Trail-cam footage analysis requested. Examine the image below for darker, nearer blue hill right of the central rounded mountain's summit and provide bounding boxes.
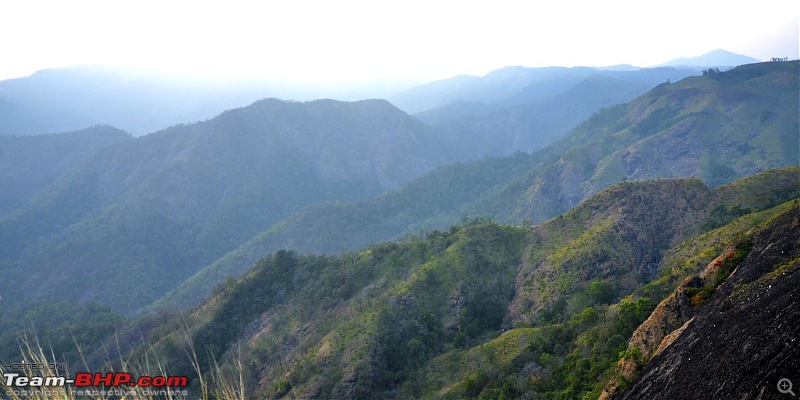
[415,68,693,158]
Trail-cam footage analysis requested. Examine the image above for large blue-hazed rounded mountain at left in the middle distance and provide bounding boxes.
[0,99,448,312]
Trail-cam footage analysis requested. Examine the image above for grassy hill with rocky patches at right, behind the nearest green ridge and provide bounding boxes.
[478,61,800,221]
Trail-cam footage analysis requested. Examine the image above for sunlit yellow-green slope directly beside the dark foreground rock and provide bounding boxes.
[408,201,798,399]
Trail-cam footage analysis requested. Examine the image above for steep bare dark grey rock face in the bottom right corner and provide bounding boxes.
[616,203,800,399]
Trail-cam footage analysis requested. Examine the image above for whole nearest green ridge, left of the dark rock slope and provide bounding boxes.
[125,168,800,398]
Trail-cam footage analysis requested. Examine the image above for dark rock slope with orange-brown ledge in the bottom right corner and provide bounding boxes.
[614,201,800,399]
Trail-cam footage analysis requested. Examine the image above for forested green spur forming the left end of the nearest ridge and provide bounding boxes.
[143,224,527,398]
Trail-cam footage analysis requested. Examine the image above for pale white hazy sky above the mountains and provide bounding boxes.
[0,0,800,80]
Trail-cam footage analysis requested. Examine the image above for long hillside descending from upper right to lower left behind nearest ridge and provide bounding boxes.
[159,61,800,305]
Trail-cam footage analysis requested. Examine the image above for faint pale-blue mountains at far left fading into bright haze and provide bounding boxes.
[0,65,422,136]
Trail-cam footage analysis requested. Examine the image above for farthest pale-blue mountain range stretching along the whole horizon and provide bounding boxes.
[0,50,758,138]
